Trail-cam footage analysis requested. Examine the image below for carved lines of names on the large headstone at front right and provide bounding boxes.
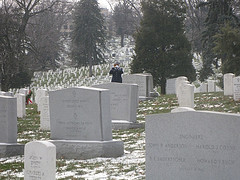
[146,134,236,171]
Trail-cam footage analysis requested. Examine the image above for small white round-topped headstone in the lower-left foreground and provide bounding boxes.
[24,141,56,180]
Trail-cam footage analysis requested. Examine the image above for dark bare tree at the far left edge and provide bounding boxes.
[0,0,60,91]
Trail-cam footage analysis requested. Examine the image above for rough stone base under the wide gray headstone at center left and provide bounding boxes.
[49,140,124,159]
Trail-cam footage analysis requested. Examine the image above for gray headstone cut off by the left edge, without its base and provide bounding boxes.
[0,96,17,143]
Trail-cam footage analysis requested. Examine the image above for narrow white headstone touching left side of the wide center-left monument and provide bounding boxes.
[40,96,50,130]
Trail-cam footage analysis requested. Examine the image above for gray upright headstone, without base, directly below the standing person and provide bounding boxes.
[94,83,138,122]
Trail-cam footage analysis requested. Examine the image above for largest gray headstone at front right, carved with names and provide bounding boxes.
[145,111,240,180]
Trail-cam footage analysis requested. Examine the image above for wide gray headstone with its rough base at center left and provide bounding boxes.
[49,87,124,159]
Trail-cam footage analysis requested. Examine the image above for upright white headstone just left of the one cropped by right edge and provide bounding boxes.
[223,73,235,96]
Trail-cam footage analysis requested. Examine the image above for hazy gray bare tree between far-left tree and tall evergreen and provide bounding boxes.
[26,2,73,70]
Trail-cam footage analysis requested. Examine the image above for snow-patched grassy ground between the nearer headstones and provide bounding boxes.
[0,92,240,180]
